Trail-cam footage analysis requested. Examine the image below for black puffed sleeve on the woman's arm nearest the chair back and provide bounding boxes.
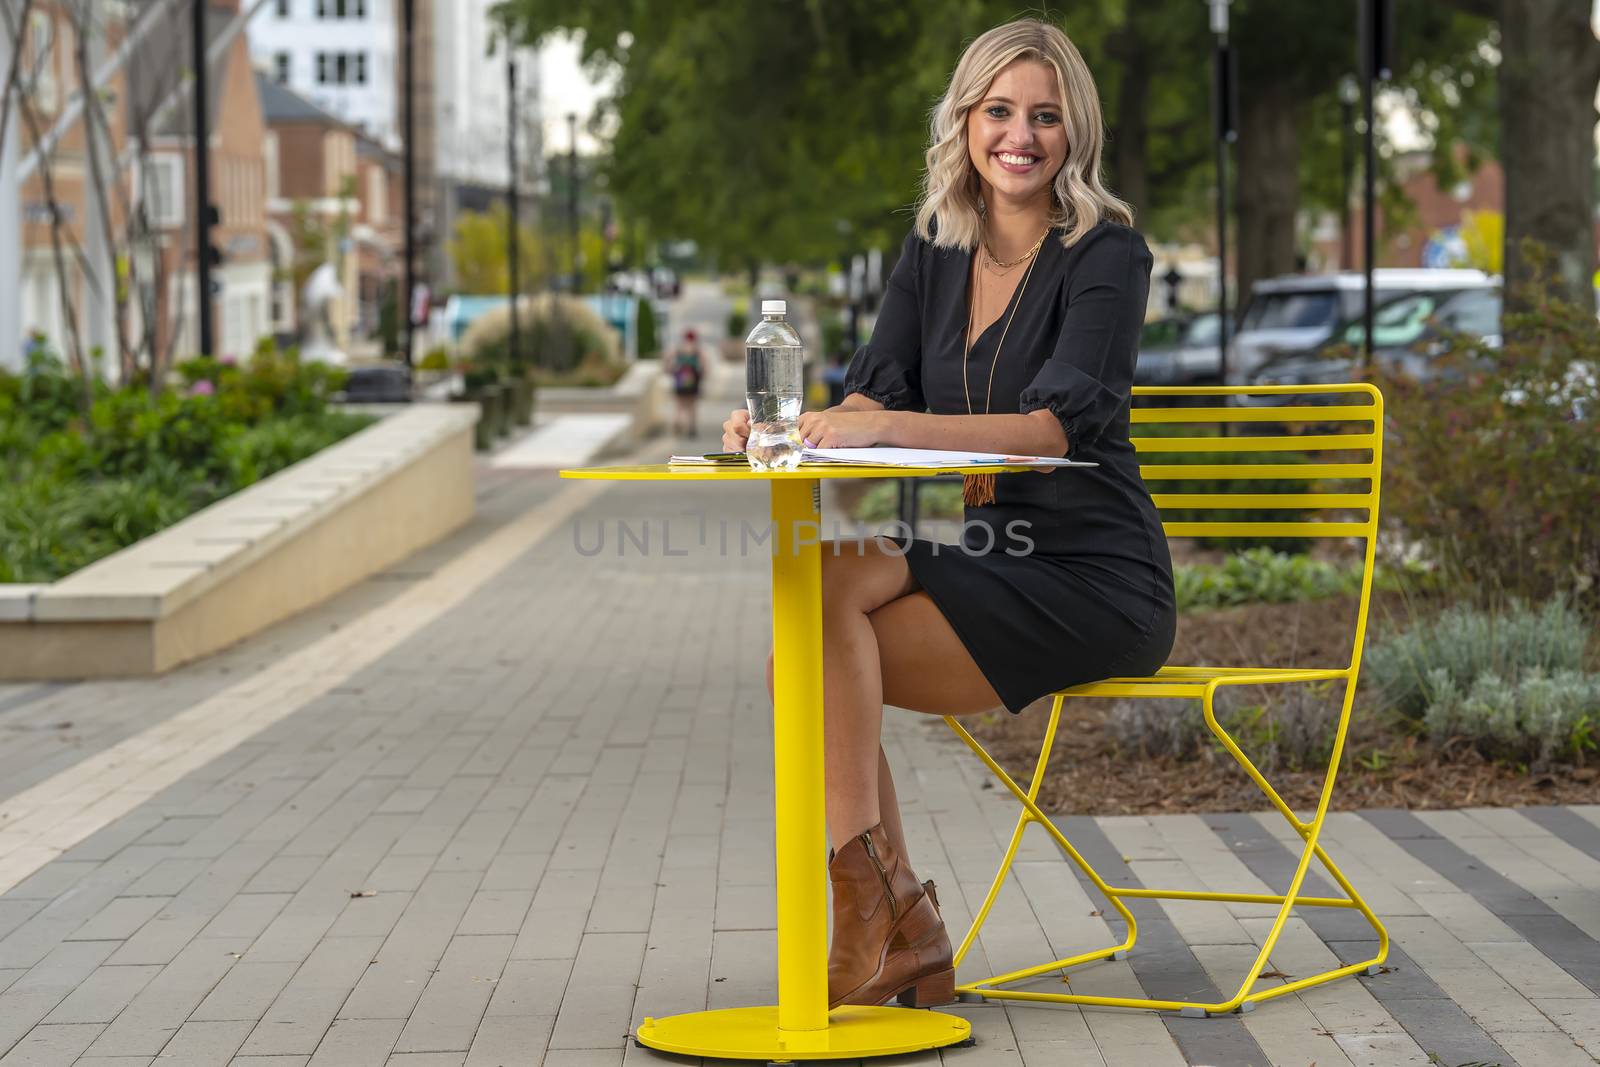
[1018,226,1154,459]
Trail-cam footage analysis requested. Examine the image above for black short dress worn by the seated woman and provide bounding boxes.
[845,222,1178,712]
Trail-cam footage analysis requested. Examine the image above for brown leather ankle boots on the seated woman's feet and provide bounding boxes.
[827,824,955,1008]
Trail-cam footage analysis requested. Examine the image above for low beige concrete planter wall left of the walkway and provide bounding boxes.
[0,405,478,681]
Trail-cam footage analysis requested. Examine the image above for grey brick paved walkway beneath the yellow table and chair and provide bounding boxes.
[0,287,1600,1067]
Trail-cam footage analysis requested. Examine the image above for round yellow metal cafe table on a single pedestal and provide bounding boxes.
[562,464,1029,1061]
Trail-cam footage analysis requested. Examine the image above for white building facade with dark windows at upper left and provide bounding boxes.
[250,0,403,149]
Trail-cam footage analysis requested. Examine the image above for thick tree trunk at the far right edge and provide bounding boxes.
[1499,0,1600,307]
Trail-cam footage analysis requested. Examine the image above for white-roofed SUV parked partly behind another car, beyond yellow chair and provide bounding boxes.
[1227,267,1496,386]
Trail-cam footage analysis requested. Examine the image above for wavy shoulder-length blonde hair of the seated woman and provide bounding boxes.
[917,19,1133,250]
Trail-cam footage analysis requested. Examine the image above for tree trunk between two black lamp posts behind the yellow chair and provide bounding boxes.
[1234,85,1299,309]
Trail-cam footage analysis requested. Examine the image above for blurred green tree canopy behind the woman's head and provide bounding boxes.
[501,0,1536,294]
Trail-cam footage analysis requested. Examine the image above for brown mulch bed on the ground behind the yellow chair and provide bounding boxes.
[938,593,1600,814]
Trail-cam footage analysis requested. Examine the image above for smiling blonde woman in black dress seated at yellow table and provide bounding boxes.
[723,21,1176,1005]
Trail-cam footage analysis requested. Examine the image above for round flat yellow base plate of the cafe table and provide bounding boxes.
[635,1006,973,1061]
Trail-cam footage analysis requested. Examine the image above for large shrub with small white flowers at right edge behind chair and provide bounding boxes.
[1374,246,1600,614]
